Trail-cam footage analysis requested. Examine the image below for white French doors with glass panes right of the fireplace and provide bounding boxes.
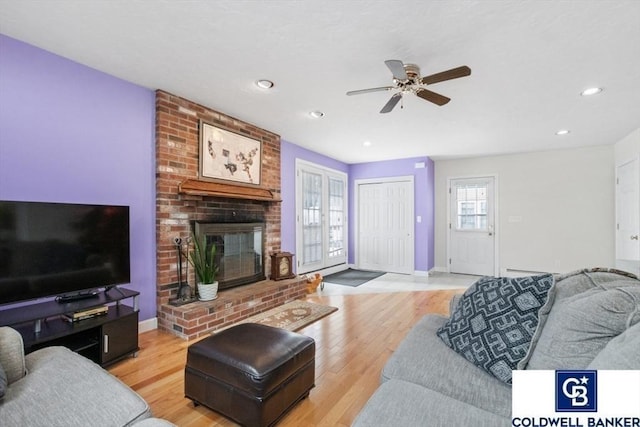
[296,161,347,273]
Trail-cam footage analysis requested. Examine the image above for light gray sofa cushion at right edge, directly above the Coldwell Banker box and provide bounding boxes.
[587,323,640,370]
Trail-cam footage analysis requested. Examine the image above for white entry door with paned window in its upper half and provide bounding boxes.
[449,177,495,276]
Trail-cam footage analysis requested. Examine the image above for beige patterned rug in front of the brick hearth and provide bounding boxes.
[225,300,338,331]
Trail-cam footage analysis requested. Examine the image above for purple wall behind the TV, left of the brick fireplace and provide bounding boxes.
[0,35,156,320]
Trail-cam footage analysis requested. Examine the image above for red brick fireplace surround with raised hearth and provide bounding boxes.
[156,90,306,340]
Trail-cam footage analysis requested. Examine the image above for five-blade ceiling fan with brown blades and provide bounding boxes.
[347,59,471,113]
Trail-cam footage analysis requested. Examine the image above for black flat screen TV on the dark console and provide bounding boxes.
[0,200,130,304]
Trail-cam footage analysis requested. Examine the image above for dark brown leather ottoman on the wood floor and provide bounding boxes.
[184,323,316,426]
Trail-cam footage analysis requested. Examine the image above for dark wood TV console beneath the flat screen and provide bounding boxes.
[0,288,140,366]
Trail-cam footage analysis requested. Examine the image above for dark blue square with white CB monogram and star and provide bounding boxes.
[556,371,598,412]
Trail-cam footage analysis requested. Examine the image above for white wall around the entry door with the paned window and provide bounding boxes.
[435,145,615,272]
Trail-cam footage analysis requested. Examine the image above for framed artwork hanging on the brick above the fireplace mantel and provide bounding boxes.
[198,120,262,186]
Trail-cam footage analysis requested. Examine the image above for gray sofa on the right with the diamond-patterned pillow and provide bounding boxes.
[353,269,640,427]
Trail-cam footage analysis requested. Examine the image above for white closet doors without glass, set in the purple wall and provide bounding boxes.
[356,177,414,274]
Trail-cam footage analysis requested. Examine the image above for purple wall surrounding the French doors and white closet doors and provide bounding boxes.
[280,141,434,271]
